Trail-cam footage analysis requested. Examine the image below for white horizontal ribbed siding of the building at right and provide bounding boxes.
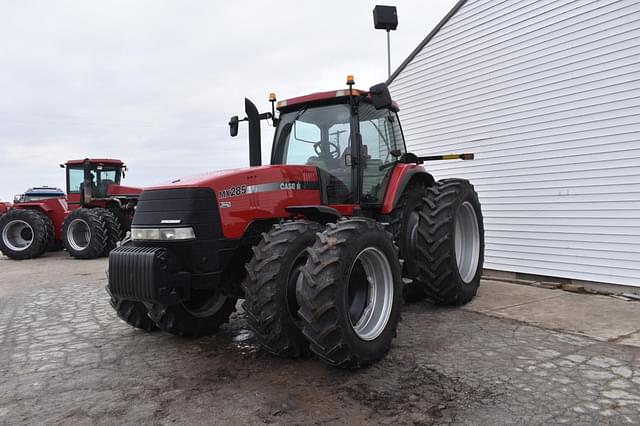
[391,0,640,286]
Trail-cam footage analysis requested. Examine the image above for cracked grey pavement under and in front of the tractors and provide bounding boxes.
[0,253,640,425]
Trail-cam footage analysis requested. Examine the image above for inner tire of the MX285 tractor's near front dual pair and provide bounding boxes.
[242,220,322,357]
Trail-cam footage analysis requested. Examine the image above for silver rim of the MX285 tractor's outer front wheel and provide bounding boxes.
[347,247,393,341]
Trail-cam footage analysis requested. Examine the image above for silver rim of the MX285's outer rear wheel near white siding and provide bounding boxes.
[455,201,480,283]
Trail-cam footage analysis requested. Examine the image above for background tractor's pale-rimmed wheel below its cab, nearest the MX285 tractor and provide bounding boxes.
[62,208,107,259]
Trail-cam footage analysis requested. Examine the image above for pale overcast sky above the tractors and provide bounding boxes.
[0,0,457,200]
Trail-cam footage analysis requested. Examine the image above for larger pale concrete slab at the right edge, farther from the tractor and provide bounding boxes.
[488,287,640,340]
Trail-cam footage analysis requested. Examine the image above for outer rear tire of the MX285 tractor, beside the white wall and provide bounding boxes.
[418,179,484,306]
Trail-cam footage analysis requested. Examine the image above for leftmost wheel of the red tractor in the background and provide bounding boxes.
[0,209,53,260]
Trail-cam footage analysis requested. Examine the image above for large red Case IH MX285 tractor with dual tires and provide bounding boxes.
[107,77,484,368]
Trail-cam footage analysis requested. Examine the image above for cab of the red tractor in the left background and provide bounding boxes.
[60,158,126,205]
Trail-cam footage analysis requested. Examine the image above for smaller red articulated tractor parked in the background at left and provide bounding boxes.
[0,159,141,260]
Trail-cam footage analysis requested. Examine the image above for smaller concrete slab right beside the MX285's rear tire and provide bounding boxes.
[464,280,563,312]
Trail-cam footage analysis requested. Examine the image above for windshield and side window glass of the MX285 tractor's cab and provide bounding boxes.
[272,102,405,203]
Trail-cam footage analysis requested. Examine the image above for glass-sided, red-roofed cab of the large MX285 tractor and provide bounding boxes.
[271,83,406,205]
